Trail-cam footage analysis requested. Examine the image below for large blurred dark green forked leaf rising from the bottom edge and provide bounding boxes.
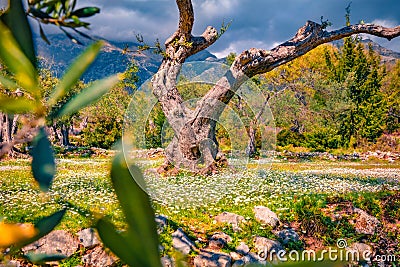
[96,153,161,267]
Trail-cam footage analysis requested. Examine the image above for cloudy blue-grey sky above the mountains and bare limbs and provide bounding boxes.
[0,0,400,57]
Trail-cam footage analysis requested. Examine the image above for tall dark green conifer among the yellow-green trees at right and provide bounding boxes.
[331,37,386,146]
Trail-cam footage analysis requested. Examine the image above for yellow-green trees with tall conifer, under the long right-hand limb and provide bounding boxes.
[265,37,400,150]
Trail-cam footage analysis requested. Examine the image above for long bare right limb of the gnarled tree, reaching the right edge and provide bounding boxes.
[191,21,400,127]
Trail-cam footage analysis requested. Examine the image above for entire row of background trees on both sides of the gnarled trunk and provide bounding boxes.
[0,37,400,157]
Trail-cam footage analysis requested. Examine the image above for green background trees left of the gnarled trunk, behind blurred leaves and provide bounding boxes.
[0,60,138,154]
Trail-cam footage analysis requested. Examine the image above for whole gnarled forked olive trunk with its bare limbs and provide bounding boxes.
[152,0,400,175]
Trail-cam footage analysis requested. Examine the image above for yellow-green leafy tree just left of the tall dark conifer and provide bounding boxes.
[263,45,347,150]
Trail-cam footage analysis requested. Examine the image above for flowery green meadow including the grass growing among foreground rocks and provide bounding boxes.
[0,158,400,266]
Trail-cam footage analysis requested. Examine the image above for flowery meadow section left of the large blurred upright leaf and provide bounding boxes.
[0,159,123,232]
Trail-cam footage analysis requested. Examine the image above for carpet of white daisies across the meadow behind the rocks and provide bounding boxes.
[0,158,400,231]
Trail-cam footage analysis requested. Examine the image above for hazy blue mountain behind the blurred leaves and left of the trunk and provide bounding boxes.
[35,34,218,83]
